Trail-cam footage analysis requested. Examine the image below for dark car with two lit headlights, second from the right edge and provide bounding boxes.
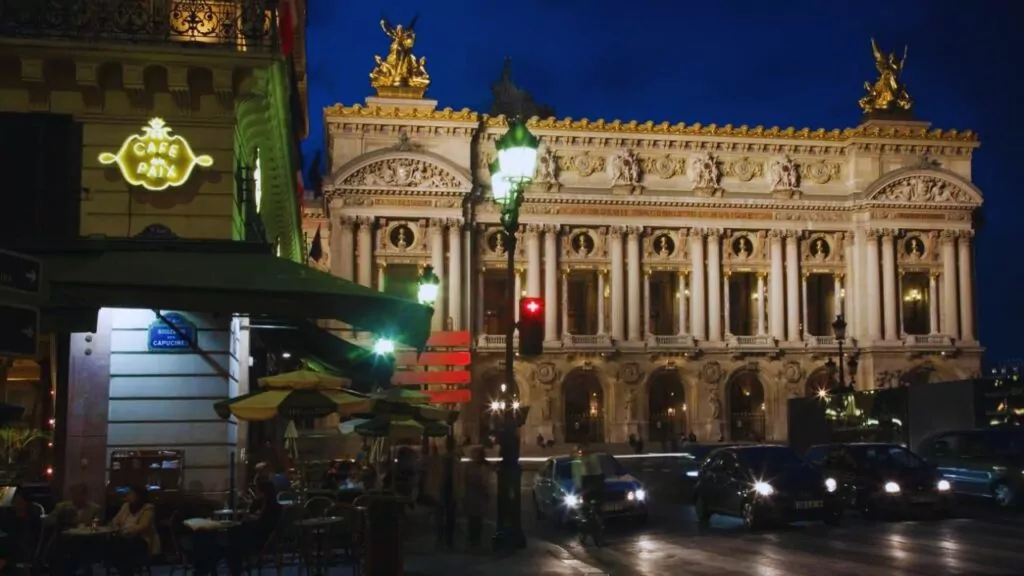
[807,443,952,518]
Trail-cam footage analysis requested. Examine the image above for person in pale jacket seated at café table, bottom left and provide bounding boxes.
[110,486,160,576]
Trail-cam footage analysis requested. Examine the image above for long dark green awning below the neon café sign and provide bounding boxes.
[25,238,433,348]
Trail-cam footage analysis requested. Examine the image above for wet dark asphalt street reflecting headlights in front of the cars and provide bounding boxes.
[523,458,1024,576]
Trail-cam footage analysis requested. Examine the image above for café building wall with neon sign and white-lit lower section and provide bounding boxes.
[0,0,308,497]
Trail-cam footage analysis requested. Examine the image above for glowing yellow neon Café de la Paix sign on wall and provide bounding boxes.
[99,118,213,191]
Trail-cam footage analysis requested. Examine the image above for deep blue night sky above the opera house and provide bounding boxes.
[303,0,1024,362]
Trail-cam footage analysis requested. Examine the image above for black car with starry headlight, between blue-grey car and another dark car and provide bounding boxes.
[693,446,843,529]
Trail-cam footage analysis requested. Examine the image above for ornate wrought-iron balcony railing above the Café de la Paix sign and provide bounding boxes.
[0,0,279,51]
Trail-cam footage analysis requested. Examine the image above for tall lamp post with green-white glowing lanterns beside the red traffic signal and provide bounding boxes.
[489,120,540,549]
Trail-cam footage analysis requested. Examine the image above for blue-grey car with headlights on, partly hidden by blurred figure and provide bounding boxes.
[532,453,647,523]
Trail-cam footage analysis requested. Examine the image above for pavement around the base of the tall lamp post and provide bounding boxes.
[403,509,604,576]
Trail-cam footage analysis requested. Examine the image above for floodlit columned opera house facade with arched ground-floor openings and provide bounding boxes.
[304,26,982,442]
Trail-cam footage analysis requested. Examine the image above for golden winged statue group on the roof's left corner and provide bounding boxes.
[370,16,430,98]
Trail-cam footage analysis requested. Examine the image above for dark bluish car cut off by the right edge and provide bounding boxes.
[918,428,1024,507]
